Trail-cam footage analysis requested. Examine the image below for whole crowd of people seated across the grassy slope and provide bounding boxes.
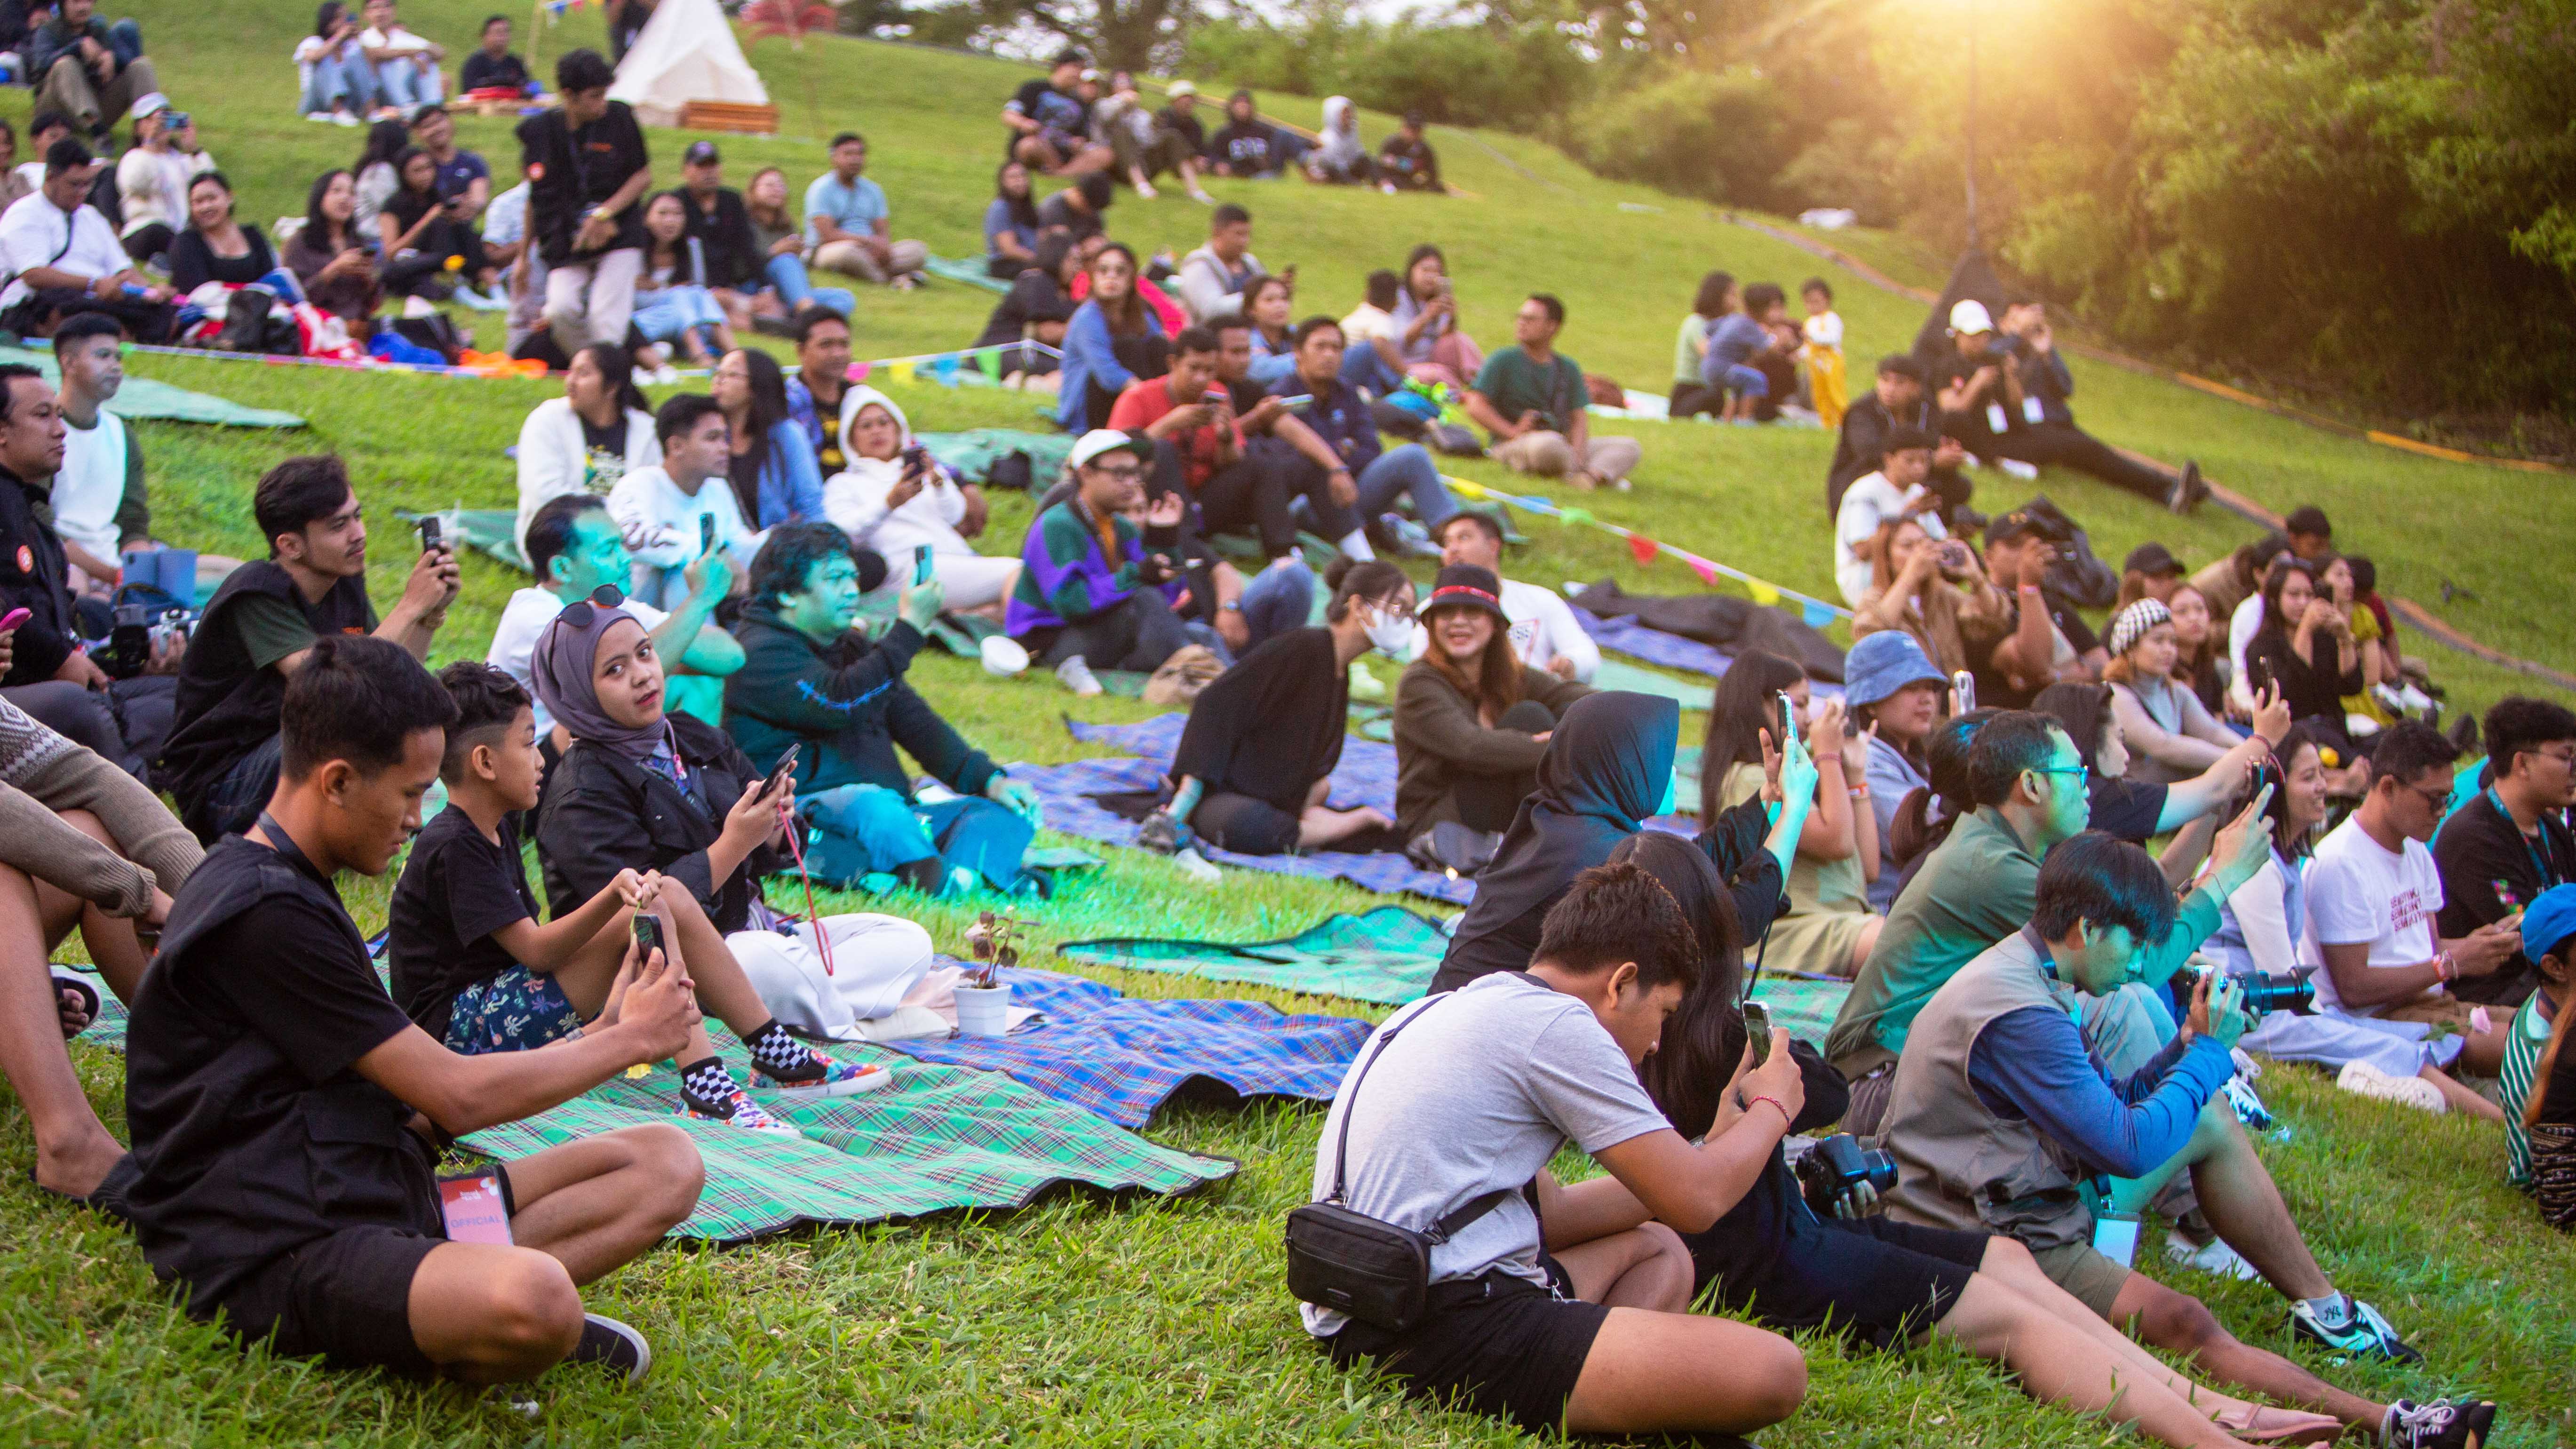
[0,25,2576,1449]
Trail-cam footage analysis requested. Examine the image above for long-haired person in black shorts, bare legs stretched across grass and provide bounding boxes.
[1613,836,2342,1447]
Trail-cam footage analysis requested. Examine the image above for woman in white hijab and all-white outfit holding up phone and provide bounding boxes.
[822,387,1020,611]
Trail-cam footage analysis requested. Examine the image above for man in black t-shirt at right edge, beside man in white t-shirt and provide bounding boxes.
[2432,693,2576,1005]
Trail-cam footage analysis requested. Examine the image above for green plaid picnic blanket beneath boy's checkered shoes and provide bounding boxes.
[60,964,1226,1243]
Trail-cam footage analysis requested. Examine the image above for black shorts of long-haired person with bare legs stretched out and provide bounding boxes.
[1718,1217,1988,1348]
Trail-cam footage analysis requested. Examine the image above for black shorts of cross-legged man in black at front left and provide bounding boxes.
[191,1222,445,1379]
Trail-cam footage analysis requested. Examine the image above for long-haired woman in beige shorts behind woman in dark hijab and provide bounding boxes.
[1700,650,1885,977]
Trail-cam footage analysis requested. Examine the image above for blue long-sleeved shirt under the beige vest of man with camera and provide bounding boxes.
[1968,925,2236,1178]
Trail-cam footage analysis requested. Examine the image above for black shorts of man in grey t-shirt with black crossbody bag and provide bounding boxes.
[1316,1268,1610,1433]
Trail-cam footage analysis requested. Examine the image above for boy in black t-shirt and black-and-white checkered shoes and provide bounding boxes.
[386,660,894,1134]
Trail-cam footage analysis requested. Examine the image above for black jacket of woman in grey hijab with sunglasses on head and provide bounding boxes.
[536,714,783,931]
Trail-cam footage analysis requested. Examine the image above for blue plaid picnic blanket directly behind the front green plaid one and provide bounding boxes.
[889,962,1370,1127]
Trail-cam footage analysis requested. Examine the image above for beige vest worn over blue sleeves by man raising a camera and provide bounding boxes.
[1880,931,2092,1248]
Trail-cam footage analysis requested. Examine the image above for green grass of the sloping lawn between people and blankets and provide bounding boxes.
[0,0,2576,1447]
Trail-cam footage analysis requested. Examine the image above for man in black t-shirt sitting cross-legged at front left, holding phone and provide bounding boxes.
[116,637,703,1382]
